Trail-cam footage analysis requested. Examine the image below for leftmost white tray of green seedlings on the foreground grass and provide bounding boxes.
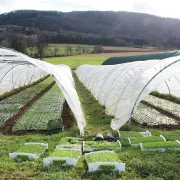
[9,142,48,161]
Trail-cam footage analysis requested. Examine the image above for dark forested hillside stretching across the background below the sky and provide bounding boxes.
[0,10,180,47]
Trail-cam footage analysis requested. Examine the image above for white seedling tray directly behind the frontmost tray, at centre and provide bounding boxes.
[83,140,121,152]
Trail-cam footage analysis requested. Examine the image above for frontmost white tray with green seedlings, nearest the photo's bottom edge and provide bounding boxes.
[85,151,125,172]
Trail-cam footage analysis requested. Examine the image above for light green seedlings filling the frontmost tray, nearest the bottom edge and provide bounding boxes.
[86,152,121,163]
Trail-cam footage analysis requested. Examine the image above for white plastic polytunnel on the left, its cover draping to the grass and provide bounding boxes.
[0,48,86,135]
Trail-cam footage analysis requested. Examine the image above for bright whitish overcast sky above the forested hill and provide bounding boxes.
[0,0,180,18]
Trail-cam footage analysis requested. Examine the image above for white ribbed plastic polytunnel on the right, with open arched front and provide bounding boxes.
[76,56,180,130]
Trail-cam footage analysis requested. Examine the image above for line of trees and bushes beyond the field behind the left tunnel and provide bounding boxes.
[11,36,104,59]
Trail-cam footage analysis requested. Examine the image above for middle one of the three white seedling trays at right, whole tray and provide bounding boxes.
[128,135,166,146]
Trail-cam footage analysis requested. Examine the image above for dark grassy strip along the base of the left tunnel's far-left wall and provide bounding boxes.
[0,75,49,101]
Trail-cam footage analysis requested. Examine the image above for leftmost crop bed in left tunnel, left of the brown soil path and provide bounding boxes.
[0,77,53,127]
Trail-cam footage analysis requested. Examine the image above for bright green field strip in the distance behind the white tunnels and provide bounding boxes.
[44,55,109,67]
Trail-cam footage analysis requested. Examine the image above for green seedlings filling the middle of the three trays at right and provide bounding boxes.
[131,136,163,144]
